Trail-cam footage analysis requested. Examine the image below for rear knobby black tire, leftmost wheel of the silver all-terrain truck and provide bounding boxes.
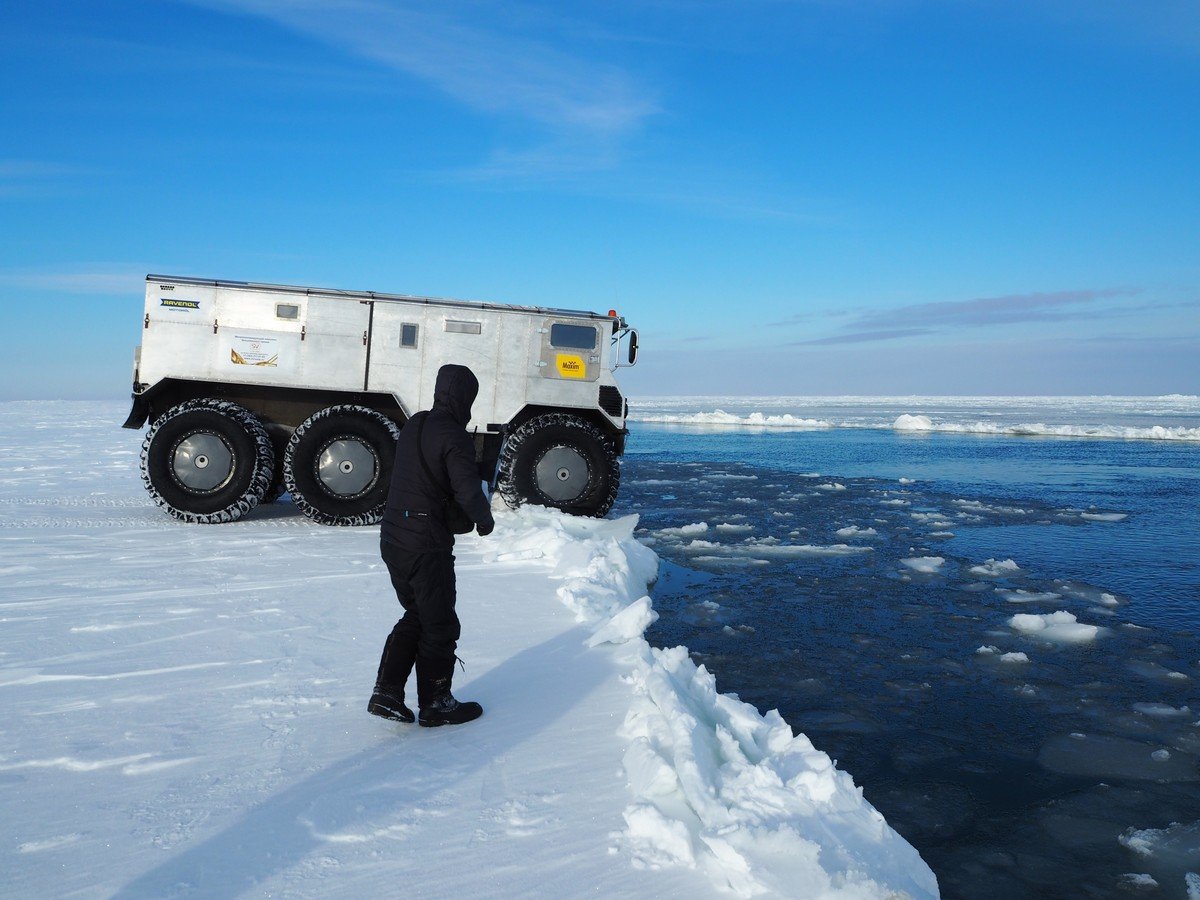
[142,398,275,524]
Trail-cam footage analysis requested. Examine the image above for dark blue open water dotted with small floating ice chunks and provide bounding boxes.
[614,424,1200,898]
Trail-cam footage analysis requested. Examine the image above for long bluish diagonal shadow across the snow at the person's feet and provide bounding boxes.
[114,628,611,900]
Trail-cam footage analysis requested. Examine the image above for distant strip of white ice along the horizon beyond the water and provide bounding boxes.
[630,394,1200,442]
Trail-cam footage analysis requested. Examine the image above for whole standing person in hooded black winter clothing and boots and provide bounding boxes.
[367,365,496,726]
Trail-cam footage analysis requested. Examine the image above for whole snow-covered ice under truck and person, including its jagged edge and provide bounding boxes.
[0,403,937,898]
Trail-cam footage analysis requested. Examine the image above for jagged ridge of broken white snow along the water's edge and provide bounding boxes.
[496,509,937,898]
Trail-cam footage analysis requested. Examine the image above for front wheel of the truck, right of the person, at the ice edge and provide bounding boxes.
[497,413,620,517]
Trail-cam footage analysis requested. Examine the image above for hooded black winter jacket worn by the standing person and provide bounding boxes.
[379,365,494,553]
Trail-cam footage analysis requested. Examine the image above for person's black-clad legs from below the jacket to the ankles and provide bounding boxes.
[376,541,462,707]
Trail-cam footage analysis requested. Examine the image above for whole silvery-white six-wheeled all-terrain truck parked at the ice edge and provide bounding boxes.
[125,275,637,524]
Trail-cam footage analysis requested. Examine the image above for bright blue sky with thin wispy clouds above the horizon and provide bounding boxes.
[0,0,1200,398]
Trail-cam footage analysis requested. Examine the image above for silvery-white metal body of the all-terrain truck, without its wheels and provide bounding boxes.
[136,275,625,432]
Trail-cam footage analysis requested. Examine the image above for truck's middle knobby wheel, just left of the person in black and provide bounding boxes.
[283,406,400,526]
